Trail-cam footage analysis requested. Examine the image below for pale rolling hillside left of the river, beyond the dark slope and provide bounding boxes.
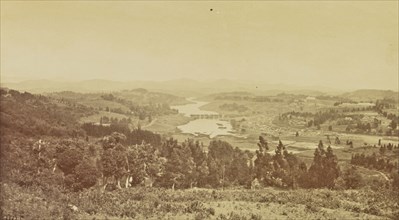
[48,89,187,126]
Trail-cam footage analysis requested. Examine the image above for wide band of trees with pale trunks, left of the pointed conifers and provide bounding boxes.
[92,133,250,189]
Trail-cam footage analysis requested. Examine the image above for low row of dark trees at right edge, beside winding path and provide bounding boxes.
[351,153,399,172]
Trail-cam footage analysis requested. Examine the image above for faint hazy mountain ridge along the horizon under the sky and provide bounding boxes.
[1,78,397,98]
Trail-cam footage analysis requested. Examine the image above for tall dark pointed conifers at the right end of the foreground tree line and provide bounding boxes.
[254,137,340,188]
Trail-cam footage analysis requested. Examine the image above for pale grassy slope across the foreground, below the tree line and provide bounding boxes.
[44,188,397,219]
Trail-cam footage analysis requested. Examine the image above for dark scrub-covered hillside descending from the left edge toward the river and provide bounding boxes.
[0,89,92,137]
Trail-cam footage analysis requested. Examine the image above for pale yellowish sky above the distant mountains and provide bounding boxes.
[1,1,398,90]
